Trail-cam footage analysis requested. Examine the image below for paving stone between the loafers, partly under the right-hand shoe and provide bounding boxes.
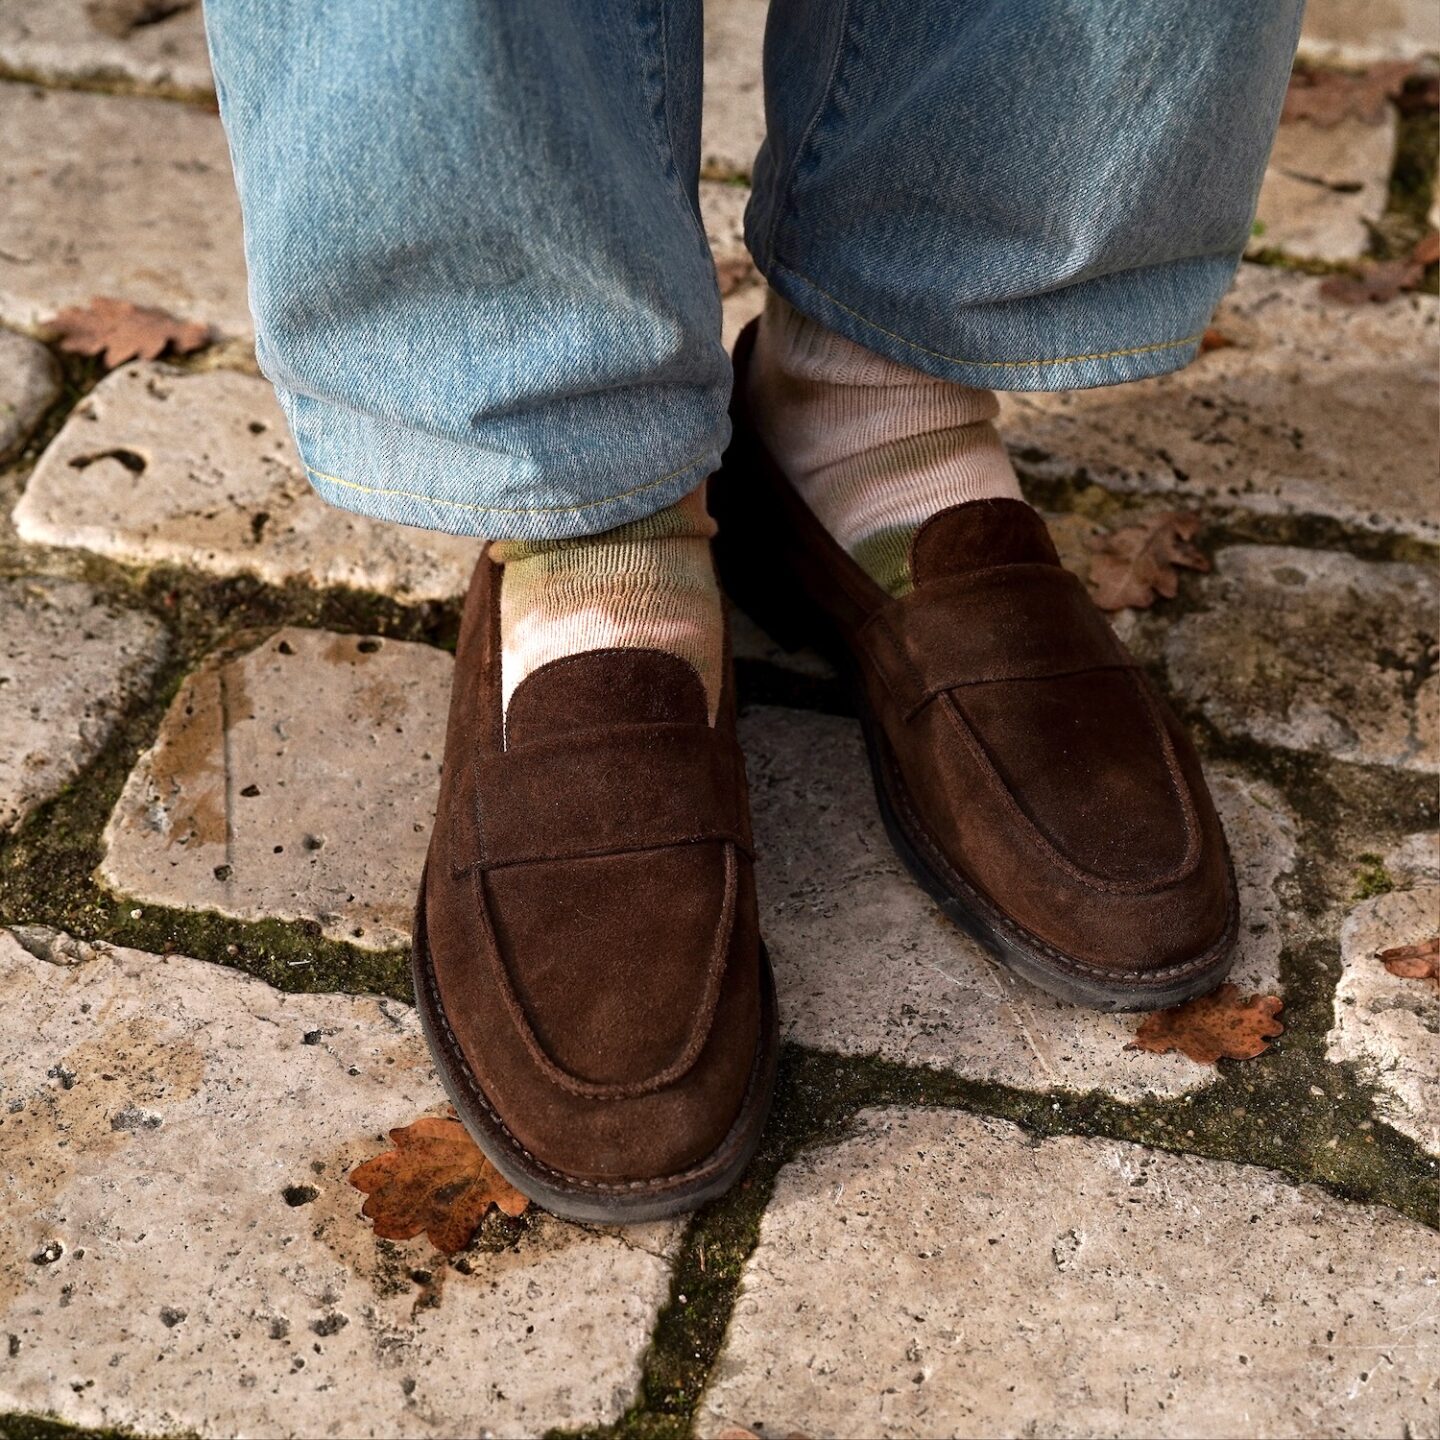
[740,707,1295,1100]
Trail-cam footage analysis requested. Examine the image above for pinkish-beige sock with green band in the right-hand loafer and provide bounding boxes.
[747,292,1024,595]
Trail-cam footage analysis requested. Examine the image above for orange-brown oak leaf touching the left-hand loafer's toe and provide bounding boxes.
[350,1115,530,1254]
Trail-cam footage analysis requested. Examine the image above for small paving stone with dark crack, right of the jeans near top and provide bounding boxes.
[1251,107,1397,261]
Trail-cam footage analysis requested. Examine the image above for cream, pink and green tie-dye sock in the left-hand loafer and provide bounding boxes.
[490,485,724,724]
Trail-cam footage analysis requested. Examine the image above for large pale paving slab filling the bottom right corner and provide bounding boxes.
[697,1110,1440,1437]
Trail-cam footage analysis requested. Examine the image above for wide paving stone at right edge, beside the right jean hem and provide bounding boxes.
[1001,265,1440,540]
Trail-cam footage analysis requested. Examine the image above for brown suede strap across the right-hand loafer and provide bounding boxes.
[860,564,1135,719]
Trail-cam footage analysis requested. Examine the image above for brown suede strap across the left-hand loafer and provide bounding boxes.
[475,724,752,870]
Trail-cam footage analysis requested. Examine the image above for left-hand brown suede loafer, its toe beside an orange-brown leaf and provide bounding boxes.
[412,544,778,1221]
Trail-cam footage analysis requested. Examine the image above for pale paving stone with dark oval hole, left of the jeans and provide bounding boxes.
[14,364,480,602]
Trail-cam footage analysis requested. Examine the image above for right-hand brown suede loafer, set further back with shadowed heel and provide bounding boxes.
[711,318,1238,1009]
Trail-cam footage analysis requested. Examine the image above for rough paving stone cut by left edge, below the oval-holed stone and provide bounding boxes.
[0,577,166,831]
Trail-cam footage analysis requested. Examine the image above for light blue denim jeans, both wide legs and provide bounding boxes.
[206,0,1302,539]
